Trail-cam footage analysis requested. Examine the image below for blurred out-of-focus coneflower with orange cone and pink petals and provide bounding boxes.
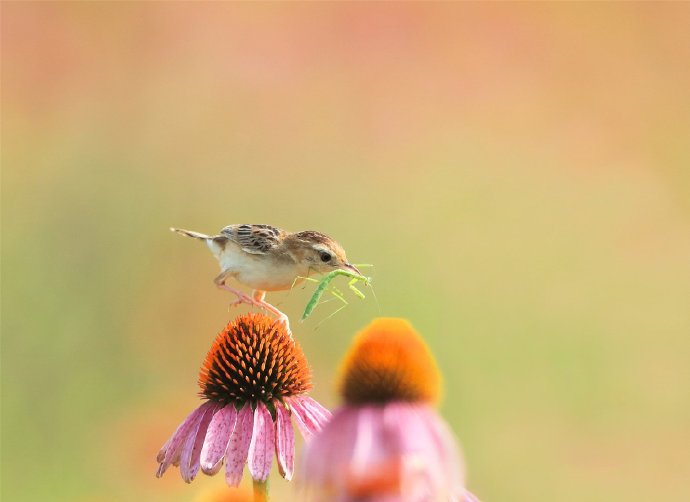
[304,319,476,502]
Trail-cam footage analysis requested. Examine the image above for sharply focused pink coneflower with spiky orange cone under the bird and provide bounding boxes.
[156,314,330,492]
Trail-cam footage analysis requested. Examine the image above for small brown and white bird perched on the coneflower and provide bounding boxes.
[170,224,361,332]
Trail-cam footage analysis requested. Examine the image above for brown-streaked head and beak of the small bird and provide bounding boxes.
[290,230,361,275]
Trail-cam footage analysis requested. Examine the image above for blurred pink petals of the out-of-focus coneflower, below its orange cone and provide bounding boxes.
[303,402,464,502]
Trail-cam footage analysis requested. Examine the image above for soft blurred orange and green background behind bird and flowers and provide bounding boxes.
[2,2,690,502]
